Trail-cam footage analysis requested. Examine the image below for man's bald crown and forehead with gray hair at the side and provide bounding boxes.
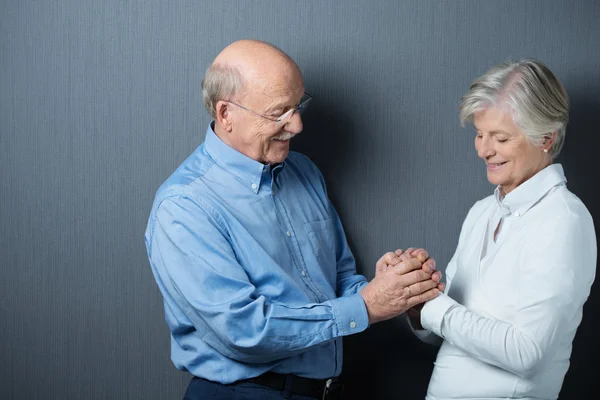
[202,40,302,118]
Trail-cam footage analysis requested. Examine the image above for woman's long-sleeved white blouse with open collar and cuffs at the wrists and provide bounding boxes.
[415,164,596,400]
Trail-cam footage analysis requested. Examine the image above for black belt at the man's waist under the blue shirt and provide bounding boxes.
[236,372,342,399]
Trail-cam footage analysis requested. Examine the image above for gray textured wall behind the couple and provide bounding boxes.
[0,0,600,399]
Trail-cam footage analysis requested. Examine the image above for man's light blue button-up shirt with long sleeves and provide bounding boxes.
[145,126,368,383]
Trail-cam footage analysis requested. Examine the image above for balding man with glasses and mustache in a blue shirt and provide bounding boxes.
[145,40,443,399]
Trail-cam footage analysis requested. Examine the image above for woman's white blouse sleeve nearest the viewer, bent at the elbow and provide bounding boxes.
[421,214,596,377]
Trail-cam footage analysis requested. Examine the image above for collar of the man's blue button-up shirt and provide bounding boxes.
[204,122,283,193]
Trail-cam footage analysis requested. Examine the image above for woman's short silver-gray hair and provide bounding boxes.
[459,59,569,158]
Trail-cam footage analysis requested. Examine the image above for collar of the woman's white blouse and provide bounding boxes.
[494,164,567,218]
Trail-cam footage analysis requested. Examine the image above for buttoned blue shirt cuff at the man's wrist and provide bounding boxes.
[330,293,369,336]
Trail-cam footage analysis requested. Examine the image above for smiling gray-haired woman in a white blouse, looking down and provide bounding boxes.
[403,60,596,400]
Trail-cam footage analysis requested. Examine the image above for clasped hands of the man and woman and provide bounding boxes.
[360,247,444,324]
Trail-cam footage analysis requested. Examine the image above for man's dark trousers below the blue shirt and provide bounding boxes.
[183,377,320,400]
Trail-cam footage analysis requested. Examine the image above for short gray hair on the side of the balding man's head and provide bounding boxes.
[202,64,243,118]
